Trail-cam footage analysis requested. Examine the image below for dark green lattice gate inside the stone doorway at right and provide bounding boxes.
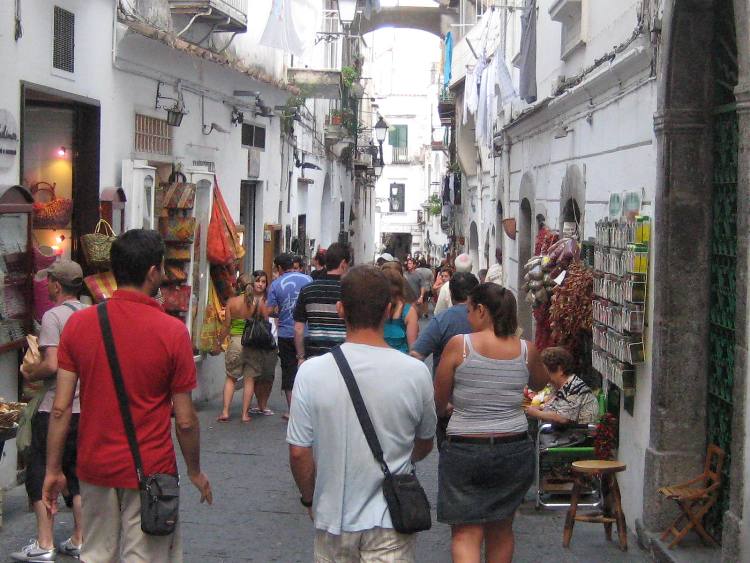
[706,1,739,539]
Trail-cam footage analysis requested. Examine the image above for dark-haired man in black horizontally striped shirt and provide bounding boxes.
[294,243,351,364]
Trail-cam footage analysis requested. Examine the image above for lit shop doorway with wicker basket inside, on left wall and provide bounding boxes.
[20,84,100,267]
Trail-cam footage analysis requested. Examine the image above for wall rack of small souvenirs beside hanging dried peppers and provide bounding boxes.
[591,216,651,415]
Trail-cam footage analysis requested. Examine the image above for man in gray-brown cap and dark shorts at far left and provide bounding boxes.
[11,260,85,561]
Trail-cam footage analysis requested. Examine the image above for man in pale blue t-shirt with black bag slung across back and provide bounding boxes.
[287,266,436,562]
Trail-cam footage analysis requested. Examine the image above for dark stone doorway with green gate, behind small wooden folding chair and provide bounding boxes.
[643,0,750,561]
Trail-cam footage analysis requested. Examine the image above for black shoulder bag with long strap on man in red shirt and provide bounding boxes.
[96,302,180,536]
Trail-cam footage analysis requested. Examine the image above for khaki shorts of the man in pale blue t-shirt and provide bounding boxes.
[315,528,417,563]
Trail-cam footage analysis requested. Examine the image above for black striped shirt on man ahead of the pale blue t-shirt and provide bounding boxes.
[294,274,346,358]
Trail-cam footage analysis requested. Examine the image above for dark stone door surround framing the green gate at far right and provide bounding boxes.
[643,0,750,561]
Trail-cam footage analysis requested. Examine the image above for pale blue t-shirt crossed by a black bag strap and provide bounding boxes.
[286,343,437,535]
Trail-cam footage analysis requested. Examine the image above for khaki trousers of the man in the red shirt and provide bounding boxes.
[81,481,182,563]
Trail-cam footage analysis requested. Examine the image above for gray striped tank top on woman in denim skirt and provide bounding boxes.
[448,334,529,436]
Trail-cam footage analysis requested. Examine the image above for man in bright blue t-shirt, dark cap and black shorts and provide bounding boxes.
[266,253,312,418]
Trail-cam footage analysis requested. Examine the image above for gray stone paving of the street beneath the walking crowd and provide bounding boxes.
[0,372,649,563]
